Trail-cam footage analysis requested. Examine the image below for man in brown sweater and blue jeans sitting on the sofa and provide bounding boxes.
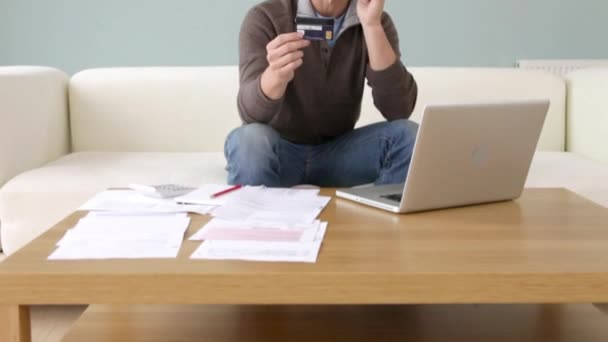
[225,0,417,187]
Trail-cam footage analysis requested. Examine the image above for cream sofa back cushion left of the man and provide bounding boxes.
[69,66,241,153]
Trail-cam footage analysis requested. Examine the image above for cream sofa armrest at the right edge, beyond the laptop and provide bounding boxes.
[566,69,608,163]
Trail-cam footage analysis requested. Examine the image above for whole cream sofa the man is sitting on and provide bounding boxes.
[0,67,608,254]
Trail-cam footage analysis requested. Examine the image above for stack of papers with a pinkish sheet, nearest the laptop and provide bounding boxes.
[191,187,330,262]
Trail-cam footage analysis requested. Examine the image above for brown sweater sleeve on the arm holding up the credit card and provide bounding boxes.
[237,8,283,123]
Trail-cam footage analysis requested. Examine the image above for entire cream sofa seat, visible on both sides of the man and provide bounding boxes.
[0,152,608,254]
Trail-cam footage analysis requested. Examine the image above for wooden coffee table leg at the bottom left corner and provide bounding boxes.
[0,305,32,342]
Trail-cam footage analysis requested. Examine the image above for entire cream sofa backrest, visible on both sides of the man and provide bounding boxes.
[69,66,566,152]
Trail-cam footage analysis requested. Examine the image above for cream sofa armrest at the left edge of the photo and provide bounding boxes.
[0,67,69,187]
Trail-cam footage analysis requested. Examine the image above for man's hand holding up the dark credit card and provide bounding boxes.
[261,32,310,100]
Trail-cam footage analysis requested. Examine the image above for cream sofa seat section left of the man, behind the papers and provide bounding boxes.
[0,152,226,254]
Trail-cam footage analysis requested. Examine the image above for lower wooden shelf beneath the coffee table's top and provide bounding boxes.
[64,304,608,342]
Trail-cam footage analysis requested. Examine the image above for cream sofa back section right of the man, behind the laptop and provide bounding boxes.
[358,67,566,152]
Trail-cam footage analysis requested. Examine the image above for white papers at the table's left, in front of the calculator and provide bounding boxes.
[49,213,190,260]
